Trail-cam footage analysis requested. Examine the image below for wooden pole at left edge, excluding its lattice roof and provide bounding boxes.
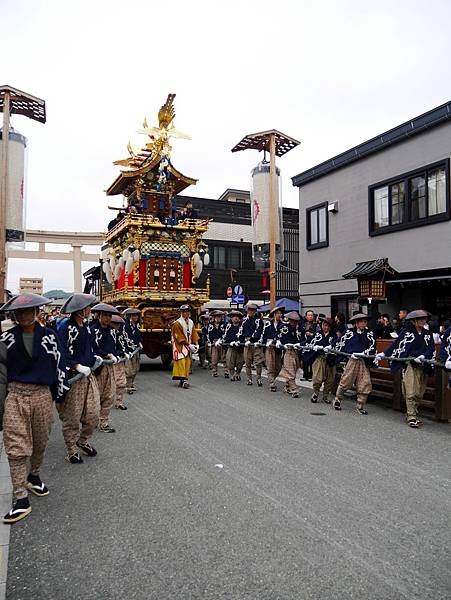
[0,92,11,304]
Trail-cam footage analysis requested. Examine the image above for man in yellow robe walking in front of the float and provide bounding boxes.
[171,304,199,389]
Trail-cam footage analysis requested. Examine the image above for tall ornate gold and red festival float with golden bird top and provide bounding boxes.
[99,94,210,365]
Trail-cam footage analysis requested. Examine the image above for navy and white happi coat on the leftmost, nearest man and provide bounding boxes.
[0,323,69,402]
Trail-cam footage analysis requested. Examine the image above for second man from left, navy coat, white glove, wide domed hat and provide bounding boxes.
[57,294,100,464]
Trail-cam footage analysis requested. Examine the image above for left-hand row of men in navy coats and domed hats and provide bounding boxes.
[0,294,142,523]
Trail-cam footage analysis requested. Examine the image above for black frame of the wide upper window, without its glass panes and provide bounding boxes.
[368,158,451,237]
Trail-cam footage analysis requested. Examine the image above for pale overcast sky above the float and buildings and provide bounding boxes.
[0,0,451,290]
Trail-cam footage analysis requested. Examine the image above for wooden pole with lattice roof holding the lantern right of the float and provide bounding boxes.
[232,129,300,309]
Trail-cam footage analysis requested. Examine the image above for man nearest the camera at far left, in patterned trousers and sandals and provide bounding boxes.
[0,294,69,523]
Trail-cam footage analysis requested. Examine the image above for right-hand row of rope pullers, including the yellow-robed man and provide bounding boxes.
[173,303,451,428]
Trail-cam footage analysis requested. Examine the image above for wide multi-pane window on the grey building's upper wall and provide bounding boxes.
[368,161,450,235]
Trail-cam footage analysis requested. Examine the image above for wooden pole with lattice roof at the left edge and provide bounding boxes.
[0,85,46,304]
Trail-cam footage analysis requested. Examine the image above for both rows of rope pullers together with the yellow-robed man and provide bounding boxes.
[0,294,451,523]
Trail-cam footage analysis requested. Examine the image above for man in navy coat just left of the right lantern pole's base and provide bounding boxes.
[239,302,265,387]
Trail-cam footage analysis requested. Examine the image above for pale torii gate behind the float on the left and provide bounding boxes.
[7,229,105,292]
